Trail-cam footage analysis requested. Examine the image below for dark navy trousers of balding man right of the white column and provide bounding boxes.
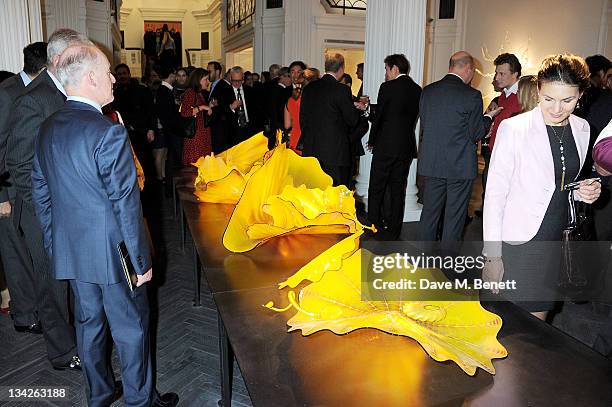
[419,177,473,242]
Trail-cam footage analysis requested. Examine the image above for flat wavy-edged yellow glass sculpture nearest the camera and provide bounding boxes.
[265,249,507,375]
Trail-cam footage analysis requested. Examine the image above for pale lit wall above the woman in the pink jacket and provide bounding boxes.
[464,0,611,103]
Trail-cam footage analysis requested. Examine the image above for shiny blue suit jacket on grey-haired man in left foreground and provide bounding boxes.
[32,101,151,284]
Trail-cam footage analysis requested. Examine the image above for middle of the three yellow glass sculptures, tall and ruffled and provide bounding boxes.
[223,144,363,253]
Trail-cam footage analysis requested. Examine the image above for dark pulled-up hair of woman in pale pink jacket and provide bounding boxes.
[538,54,590,92]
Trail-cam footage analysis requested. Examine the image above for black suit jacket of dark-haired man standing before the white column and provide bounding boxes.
[368,75,421,158]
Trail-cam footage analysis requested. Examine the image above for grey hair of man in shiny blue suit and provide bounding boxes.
[56,45,103,88]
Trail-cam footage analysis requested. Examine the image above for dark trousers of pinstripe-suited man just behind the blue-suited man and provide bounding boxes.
[18,199,76,365]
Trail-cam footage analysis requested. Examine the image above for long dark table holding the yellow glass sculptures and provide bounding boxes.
[178,173,612,407]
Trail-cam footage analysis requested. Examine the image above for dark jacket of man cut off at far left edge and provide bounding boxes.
[0,75,25,202]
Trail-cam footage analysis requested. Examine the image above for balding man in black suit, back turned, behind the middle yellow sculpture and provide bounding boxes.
[300,54,360,187]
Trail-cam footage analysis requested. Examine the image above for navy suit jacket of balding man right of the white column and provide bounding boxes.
[418,74,492,179]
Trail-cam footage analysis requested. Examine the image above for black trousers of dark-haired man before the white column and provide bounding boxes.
[368,154,412,239]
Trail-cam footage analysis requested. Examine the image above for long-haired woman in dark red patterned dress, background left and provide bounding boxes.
[181,68,212,165]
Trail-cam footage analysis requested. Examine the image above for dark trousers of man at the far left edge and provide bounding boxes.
[0,206,38,326]
